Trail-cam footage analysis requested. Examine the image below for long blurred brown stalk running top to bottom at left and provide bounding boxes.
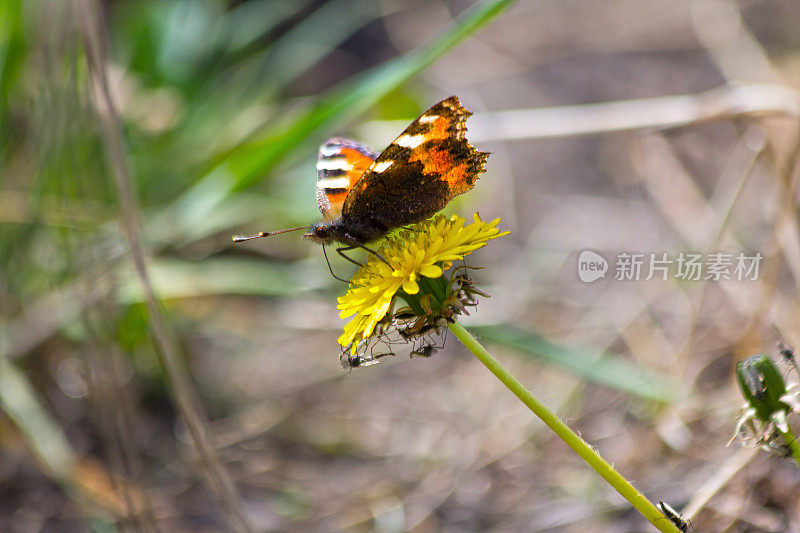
[79,0,252,531]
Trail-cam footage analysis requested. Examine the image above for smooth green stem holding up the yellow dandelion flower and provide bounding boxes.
[450,322,680,533]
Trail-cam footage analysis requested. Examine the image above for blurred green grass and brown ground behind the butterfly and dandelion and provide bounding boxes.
[0,0,800,532]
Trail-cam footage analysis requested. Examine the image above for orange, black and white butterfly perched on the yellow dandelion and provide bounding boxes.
[233,96,489,276]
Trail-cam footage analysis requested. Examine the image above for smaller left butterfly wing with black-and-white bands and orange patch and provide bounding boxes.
[317,138,378,221]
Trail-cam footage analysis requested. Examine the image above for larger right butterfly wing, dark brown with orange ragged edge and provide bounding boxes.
[342,96,489,234]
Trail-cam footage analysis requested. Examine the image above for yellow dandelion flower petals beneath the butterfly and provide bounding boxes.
[338,213,509,353]
